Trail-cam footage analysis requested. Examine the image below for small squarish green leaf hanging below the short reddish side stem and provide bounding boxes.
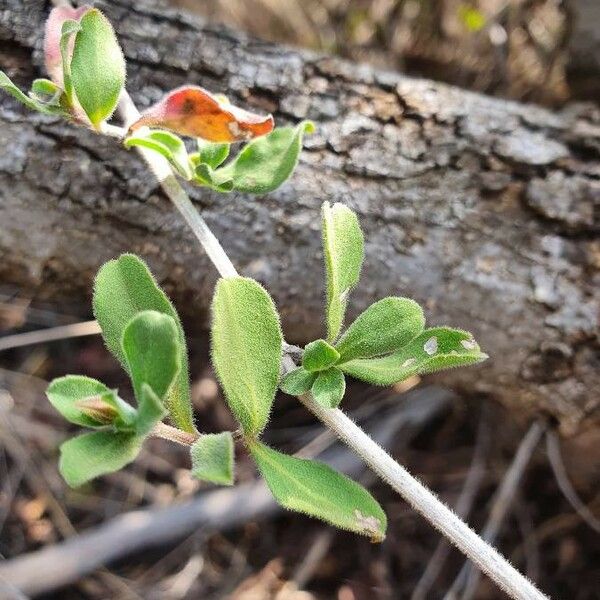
[190,431,233,485]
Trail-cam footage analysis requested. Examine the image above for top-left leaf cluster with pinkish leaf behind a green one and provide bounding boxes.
[0,6,125,130]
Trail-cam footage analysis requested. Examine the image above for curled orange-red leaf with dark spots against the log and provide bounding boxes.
[129,86,273,143]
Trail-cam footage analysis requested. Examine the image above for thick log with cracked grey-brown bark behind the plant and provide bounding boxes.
[0,0,600,433]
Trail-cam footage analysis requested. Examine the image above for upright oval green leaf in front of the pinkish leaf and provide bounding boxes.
[71,9,125,129]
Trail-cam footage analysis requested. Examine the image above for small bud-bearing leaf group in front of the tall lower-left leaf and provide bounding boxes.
[47,311,181,486]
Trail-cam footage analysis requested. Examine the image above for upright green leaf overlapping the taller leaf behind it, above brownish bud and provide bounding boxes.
[122,310,183,402]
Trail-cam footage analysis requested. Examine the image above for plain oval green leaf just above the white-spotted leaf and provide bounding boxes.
[335,297,425,363]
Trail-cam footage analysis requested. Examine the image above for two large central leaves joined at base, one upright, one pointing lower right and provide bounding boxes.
[211,277,386,541]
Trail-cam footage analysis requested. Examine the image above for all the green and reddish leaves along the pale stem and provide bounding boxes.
[22,6,486,541]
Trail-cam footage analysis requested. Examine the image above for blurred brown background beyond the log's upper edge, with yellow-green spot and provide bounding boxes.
[177,0,600,106]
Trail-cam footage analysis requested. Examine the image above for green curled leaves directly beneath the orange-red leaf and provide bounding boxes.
[125,122,314,194]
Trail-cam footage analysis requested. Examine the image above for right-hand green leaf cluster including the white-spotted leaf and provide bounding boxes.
[281,202,487,408]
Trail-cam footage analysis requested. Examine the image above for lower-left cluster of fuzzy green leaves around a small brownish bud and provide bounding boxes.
[47,254,233,487]
